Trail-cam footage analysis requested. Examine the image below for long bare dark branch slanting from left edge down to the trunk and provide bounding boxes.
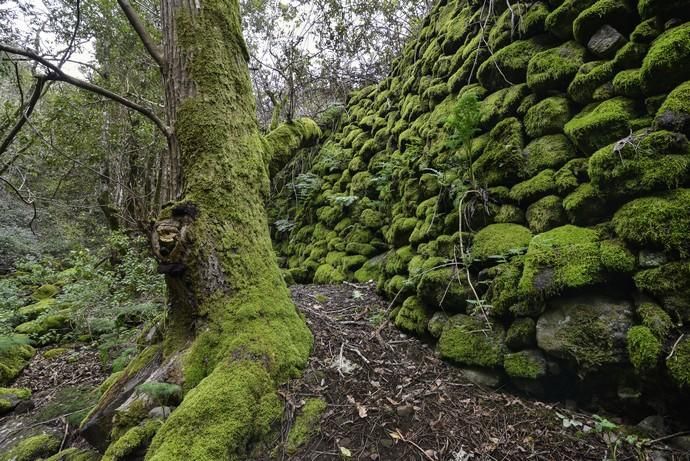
[0,43,171,138]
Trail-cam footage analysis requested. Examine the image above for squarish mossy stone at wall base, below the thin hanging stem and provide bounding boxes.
[438,314,504,368]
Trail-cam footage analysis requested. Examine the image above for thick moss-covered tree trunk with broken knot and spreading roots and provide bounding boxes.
[80,0,312,461]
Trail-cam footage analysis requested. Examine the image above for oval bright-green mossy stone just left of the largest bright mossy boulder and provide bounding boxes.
[470,224,532,261]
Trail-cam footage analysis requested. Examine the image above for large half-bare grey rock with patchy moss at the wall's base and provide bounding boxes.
[537,295,633,372]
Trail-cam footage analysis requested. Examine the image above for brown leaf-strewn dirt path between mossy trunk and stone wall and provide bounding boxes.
[282,284,689,461]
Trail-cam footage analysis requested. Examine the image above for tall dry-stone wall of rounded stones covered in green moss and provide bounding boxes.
[269,0,690,410]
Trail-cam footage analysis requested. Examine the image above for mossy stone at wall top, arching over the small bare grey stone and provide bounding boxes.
[573,0,637,44]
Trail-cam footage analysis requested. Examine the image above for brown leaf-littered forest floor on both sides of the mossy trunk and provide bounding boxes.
[0,283,690,461]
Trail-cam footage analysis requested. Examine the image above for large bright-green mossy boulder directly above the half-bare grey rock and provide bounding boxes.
[519,225,603,297]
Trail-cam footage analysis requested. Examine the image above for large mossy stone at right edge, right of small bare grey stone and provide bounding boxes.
[641,23,690,96]
